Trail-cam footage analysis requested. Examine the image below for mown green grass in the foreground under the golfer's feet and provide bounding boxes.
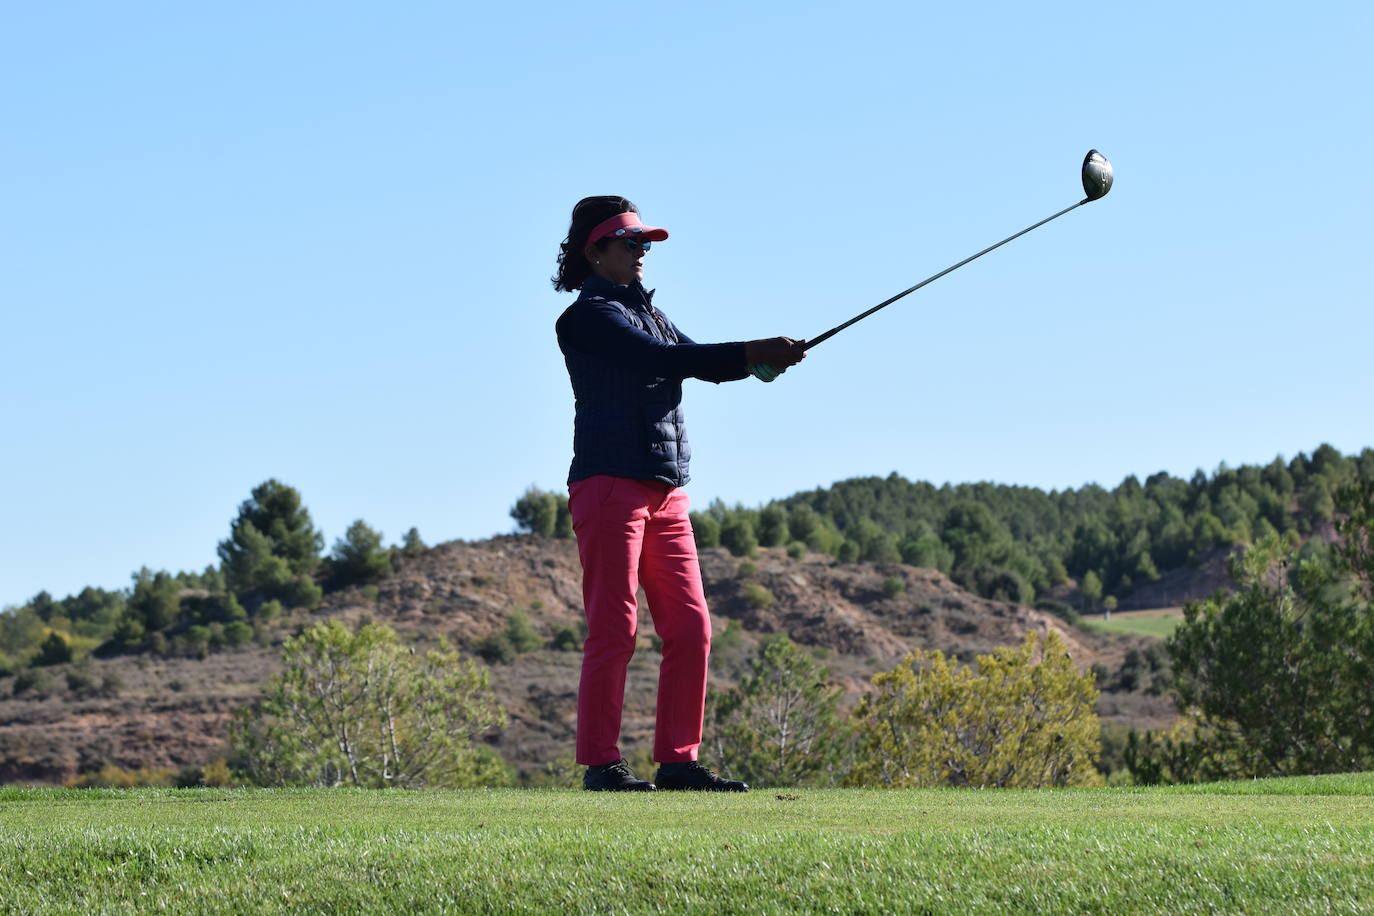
[0,773,1374,913]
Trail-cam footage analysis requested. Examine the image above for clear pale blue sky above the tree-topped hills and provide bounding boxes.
[0,1,1374,606]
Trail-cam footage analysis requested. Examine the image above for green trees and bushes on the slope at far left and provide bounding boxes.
[0,479,426,674]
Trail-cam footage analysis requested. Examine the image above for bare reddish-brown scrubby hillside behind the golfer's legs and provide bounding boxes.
[0,536,1172,783]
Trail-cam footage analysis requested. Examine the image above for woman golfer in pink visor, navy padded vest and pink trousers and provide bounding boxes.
[554,196,805,792]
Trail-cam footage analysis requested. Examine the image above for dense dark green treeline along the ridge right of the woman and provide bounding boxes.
[511,445,1374,606]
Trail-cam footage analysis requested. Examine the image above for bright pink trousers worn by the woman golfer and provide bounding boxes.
[567,475,710,766]
